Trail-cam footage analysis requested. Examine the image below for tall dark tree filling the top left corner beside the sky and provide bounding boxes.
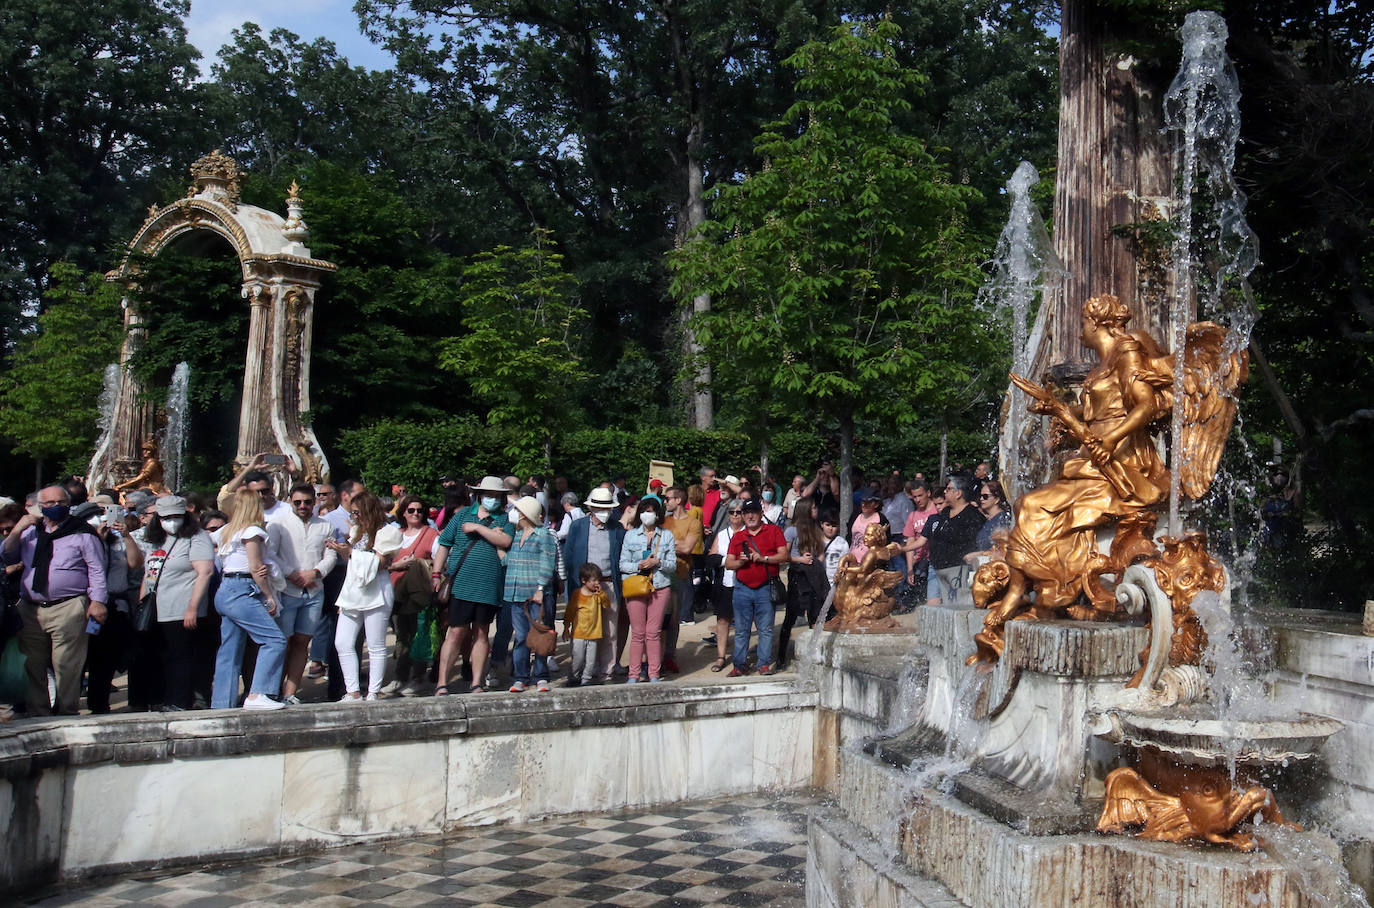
[0,0,198,343]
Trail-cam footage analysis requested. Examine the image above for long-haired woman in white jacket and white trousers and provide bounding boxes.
[326,492,401,701]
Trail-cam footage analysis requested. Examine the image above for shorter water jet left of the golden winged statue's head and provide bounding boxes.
[978,161,1066,497]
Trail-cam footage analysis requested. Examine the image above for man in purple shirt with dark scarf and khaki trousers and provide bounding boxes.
[3,485,109,716]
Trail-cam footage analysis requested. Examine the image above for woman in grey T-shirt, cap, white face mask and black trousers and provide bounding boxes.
[139,495,214,712]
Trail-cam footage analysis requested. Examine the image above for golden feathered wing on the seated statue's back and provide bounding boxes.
[1175,321,1250,499]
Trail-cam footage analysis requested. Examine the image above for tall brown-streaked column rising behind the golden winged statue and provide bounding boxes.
[1031,0,1172,376]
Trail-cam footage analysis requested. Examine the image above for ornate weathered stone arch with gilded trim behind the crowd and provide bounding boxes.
[88,151,337,488]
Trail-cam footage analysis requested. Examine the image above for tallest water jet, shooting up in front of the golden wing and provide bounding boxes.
[1164,11,1256,536]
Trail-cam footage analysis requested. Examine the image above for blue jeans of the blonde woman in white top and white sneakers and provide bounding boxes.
[210,577,286,709]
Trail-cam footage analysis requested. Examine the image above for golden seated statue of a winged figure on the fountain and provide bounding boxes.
[969,294,1248,663]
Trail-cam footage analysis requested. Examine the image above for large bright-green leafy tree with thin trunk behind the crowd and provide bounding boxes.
[673,19,978,517]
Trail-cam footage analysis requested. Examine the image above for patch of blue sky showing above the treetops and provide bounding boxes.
[185,0,392,76]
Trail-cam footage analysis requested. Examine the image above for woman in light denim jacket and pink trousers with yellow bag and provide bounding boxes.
[620,495,677,684]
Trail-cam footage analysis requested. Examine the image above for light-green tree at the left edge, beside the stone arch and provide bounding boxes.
[0,264,122,473]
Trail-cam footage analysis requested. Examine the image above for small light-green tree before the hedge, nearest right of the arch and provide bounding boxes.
[438,229,587,470]
